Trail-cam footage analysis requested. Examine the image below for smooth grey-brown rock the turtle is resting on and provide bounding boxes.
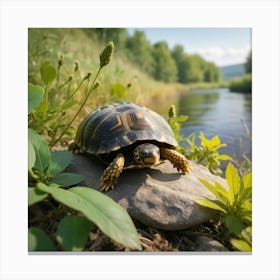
[67,154,227,230]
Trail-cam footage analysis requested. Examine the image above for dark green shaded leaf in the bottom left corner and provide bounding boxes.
[28,227,56,251]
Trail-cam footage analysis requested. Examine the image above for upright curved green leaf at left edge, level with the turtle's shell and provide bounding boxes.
[28,128,51,172]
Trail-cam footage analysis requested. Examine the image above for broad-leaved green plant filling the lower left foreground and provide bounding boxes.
[28,129,141,250]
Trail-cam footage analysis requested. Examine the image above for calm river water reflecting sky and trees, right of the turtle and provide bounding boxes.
[151,88,252,160]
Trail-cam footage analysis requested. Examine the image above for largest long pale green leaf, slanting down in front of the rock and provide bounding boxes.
[38,183,142,250]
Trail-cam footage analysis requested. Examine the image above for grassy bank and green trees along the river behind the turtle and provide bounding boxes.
[28,28,253,117]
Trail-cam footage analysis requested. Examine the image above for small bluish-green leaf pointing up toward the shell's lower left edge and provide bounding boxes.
[48,151,72,177]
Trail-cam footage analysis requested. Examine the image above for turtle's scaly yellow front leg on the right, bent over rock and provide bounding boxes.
[160,148,190,174]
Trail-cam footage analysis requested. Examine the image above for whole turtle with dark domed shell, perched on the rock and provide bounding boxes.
[72,102,190,191]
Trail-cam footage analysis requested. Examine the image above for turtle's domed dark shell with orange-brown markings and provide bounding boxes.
[75,102,177,160]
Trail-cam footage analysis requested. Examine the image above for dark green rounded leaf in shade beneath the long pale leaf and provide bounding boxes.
[56,216,93,251]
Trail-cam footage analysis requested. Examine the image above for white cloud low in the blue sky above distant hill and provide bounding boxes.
[189,45,251,66]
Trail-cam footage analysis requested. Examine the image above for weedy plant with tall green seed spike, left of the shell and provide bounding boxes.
[28,42,114,147]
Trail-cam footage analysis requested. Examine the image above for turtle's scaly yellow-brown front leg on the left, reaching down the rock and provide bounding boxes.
[100,154,124,191]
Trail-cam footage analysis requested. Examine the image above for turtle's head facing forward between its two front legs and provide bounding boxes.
[134,143,160,165]
